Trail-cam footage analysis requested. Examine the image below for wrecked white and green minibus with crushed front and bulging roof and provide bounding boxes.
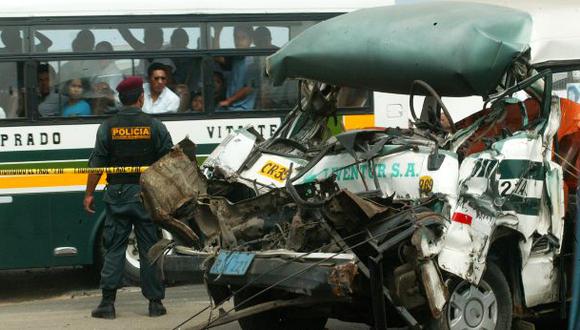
[141,1,580,329]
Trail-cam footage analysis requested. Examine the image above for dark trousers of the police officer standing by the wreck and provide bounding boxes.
[101,202,165,300]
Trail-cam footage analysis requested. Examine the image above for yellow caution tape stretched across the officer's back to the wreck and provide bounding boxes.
[0,166,148,176]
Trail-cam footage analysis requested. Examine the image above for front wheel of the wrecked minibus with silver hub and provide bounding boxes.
[436,262,512,330]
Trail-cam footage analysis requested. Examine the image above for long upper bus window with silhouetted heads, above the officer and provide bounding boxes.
[34,24,201,53]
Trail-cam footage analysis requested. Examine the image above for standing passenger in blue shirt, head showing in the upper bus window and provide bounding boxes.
[216,24,257,110]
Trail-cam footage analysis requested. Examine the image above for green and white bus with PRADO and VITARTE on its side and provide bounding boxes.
[0,0,384,279]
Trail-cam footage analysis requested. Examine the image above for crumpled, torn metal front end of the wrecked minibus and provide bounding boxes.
[141,133,447,328]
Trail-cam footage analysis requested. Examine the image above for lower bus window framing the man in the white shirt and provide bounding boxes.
[37,57,207,117]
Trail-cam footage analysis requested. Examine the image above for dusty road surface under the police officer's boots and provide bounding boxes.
[0,268,369,330]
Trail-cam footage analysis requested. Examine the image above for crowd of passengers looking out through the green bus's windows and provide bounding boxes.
[0,25,297,117]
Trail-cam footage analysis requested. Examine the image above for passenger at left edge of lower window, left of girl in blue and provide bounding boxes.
[36,63,68,117]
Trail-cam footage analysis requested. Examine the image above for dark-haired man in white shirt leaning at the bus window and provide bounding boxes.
[143,63,179,114]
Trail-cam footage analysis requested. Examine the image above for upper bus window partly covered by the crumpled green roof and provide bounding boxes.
[209,21,314,50]
